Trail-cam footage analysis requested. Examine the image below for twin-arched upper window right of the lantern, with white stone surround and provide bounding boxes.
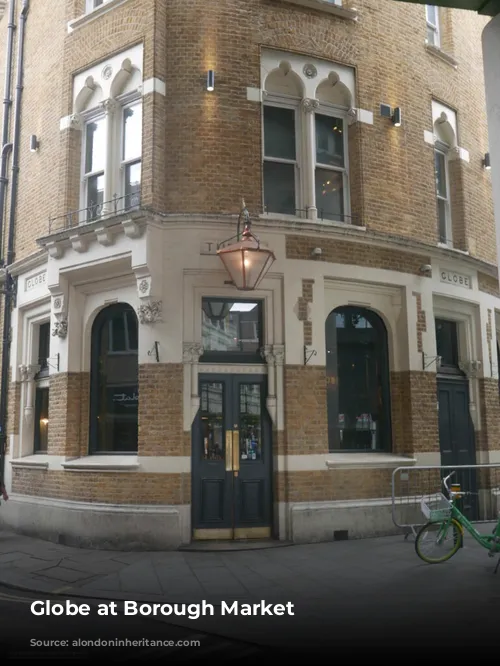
[262,56,354,223]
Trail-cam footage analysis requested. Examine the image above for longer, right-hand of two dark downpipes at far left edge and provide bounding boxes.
[0,0,29,489]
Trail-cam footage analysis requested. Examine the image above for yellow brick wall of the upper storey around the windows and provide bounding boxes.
[0,0,496,263]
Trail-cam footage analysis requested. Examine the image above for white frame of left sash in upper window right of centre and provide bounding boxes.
[262,94,305,217]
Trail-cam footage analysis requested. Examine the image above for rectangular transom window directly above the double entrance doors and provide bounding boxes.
[202,298,262,360]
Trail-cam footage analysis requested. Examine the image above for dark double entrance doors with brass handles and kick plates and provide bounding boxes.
[192,375,272,539]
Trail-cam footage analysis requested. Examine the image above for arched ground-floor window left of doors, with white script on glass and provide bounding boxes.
[90,303,139,454]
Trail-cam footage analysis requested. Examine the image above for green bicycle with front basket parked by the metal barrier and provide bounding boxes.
[415,472,500,573]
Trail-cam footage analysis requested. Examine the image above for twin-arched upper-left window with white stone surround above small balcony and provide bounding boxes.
[72,45,143,223]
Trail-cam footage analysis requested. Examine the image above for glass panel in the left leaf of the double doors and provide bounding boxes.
[200,382,225,460]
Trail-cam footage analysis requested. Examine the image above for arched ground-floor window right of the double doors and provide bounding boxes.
[326,306,391,451]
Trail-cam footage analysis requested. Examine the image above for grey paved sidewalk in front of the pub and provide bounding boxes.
[0,532,500,646]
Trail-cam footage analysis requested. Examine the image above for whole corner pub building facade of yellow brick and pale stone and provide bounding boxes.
[0,0,500,548]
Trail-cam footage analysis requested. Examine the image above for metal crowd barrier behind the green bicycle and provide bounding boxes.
[392,463,500,538]
